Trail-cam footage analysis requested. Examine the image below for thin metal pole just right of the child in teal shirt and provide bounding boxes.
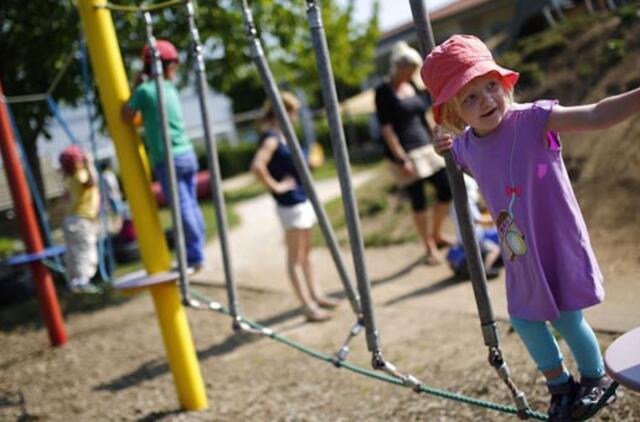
[187,0,240,328]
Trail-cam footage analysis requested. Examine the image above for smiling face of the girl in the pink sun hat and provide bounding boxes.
[457,73,509,136]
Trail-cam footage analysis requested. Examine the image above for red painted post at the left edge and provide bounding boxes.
[0,83,67,346]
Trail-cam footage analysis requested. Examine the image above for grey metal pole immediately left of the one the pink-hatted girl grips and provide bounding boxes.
[307,0,381,354]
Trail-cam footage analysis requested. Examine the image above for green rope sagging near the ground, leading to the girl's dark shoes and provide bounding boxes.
[191,290,547,421]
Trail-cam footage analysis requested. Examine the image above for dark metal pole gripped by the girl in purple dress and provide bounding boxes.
[409,0,529,419]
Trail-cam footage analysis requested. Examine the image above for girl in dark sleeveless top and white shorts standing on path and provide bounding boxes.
[251,92,337,322]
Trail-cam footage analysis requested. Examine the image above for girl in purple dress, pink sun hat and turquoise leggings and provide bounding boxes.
[421,35,640,421]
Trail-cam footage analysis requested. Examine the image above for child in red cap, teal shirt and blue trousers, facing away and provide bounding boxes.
[122,40,205,271]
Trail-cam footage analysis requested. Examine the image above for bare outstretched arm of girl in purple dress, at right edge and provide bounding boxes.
[546,88,640,132]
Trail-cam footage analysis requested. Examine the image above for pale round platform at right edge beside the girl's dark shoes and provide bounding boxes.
[604,327,640,392]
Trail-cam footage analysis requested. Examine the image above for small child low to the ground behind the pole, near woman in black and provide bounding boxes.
[447,174,500,279]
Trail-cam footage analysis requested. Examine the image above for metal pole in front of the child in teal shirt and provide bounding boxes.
[144,12,189,304]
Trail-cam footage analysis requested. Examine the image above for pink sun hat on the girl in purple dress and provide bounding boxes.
[420,35,520,123]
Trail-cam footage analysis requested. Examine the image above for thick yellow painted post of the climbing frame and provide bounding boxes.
[78,0,208,410]
